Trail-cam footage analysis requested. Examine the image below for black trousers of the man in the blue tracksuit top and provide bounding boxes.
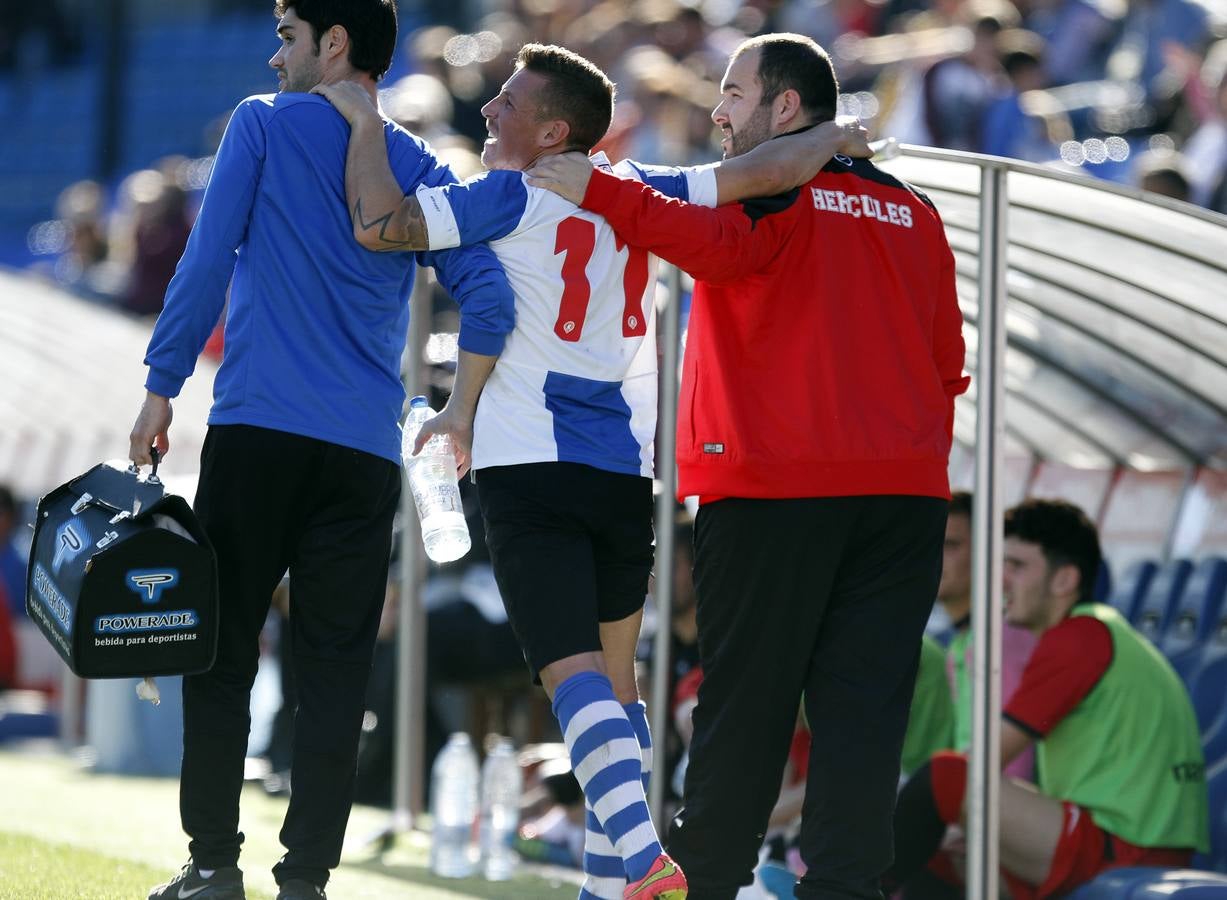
[179,425,400,885]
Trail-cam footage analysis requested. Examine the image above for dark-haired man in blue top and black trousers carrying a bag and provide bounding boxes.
[130,7,513,900]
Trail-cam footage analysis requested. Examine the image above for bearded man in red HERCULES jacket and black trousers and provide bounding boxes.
[529,34,968,900]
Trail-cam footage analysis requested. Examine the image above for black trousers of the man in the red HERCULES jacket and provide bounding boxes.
[667,496,947,900]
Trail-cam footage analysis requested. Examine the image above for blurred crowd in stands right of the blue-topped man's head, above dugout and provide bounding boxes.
[377,0,1227,205]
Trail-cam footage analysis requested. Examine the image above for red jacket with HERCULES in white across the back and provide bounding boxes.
[583,157,969,497]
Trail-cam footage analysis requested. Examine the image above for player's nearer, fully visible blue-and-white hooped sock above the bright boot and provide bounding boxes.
[553,672,661,879]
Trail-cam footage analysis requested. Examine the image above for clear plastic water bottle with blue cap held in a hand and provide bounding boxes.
[400,397,471,562]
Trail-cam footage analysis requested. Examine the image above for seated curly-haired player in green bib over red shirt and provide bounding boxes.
[887,500,1209,899]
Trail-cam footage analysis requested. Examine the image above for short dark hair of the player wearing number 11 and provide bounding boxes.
[515,44,615,153]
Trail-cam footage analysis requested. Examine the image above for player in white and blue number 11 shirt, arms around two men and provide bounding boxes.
[317,44,867,898]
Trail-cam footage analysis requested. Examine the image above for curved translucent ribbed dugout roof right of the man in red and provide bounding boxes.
[882,146,1227,471]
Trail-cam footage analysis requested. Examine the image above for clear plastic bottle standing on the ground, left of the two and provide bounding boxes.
[431,732,477,878]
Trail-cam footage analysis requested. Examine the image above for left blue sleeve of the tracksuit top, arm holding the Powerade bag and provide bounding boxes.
[145,98,265,397]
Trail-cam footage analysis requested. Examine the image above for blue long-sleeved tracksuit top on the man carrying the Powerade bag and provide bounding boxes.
[145,93,514,462]
